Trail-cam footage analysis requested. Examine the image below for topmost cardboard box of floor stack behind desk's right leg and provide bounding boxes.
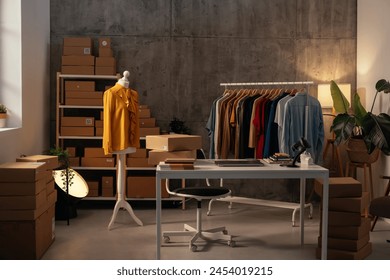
[314,177,363,198]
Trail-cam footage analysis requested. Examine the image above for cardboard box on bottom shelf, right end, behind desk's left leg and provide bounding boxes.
[127,176,169,198]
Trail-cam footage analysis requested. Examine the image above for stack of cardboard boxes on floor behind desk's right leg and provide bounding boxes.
[314,177,372,260]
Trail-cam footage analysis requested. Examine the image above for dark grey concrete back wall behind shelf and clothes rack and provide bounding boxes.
[50,0,357,201]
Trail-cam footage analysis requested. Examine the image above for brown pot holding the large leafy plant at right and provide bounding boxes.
[346,138,380,163]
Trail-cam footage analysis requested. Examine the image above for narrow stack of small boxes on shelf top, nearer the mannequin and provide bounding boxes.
[95,38,116,75]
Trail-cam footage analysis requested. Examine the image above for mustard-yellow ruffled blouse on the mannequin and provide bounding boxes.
[103,83,139,154]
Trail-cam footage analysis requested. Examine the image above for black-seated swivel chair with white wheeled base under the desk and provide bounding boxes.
[163,150,235,252]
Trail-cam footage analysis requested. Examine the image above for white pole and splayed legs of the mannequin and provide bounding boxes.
[108,153,143,230]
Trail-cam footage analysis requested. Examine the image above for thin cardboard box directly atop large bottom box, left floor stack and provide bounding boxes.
[0,190,57,221]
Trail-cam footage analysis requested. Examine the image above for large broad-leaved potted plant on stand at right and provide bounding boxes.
[330,79,390,163]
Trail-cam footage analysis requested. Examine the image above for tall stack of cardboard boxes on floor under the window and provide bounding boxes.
[0,155,58,259]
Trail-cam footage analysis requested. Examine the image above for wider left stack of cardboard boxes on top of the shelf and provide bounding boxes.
[61,37,95,75]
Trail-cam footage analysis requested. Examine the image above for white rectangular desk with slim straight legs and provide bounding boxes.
[156,160,329,259]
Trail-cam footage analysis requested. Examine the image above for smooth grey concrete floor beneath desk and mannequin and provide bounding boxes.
[42,201,390,260]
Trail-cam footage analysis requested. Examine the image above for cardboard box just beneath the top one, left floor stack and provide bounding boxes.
[0,178,47,196]
